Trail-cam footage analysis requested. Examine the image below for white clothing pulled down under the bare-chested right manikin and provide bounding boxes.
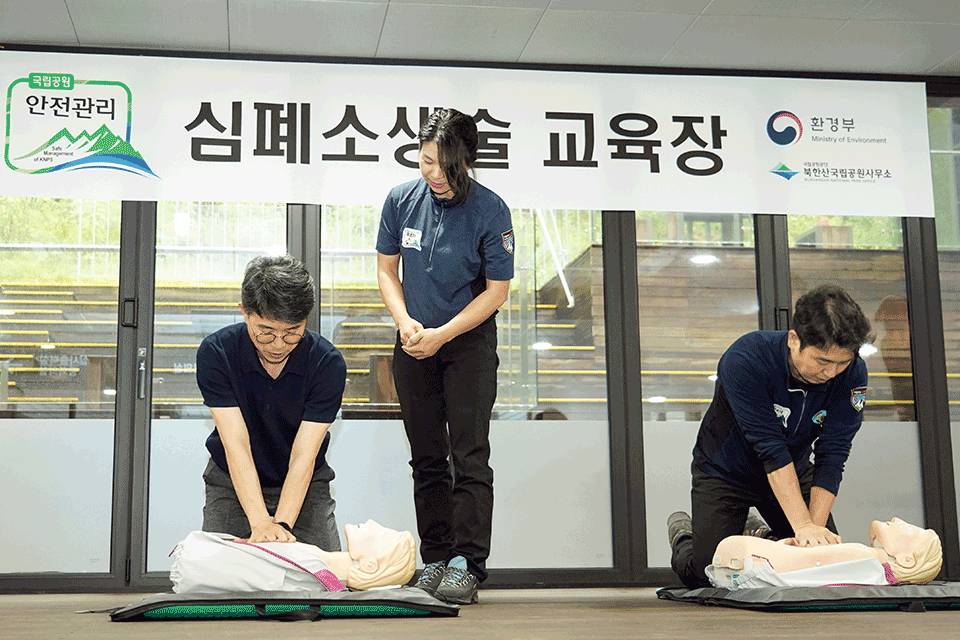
[705,558,897,591]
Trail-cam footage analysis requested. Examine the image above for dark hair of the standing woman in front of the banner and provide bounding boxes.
[418,109,479,206]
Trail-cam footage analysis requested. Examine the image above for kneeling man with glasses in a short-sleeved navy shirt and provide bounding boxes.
[197,256,346,551]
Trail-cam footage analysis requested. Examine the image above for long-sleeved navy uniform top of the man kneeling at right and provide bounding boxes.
[693,331,867,495]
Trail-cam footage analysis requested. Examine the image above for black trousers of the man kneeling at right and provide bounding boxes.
[670,465,837,589]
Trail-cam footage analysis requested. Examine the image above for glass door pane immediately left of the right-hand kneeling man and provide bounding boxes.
[636,211,759,567]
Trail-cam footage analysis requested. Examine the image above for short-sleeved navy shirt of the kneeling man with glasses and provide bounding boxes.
[197,322,347,487]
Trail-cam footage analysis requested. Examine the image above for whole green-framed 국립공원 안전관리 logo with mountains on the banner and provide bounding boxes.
[4,73,158,178]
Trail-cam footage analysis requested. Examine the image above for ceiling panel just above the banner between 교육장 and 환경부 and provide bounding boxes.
[662,16,844,70]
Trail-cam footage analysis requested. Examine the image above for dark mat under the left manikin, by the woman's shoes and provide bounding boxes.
[109,587,460,622]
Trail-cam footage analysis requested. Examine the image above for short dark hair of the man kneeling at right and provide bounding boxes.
[793,284,873,356]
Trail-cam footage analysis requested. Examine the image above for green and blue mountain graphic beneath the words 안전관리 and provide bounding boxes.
[7,125,159,178]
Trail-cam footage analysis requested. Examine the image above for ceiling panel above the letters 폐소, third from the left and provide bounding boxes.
[230,0,387,58]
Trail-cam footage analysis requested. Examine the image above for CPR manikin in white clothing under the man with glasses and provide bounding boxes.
[170,520,416,594]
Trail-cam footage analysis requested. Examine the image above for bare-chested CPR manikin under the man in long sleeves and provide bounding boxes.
[706,518,943,589]
